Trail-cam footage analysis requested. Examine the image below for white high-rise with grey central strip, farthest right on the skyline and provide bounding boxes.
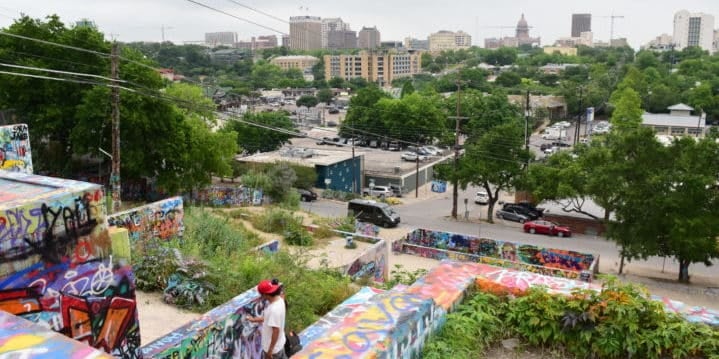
[672,10,714,51]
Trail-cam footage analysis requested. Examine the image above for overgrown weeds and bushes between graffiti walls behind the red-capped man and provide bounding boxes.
[133,208,355,330]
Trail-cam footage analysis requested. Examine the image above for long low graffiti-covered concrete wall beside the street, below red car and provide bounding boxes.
[393,229,599,281]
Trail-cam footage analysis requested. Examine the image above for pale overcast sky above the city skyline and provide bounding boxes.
[0,0,719,48]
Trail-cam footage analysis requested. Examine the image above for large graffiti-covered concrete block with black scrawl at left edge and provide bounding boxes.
[0,172,140,358]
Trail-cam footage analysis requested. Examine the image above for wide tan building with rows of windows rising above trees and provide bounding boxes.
[324,51,422,86]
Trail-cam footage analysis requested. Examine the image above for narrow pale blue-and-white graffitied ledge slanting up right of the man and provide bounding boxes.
[299,287,384,345]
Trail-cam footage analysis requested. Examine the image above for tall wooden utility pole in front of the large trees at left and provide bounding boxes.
[110,42,122,213]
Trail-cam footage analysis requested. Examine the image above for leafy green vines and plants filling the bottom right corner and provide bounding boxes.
[424,279,719,358]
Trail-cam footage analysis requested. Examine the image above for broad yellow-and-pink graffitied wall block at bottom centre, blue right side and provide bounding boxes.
[292,291,434,359]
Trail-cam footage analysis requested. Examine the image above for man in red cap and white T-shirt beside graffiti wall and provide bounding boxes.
[249,279,287,359]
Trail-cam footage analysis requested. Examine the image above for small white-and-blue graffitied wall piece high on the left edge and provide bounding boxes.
[0,124,32,174]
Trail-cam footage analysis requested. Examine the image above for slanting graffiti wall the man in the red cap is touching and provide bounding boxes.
[141,288,265,359]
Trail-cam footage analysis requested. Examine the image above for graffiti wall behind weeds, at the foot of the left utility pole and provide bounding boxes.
[107,197,185,243]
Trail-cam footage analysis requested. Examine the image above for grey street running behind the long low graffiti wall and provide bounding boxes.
[302,188,719,286]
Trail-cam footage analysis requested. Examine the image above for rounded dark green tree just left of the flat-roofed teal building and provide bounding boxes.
[223,112,294,153]
